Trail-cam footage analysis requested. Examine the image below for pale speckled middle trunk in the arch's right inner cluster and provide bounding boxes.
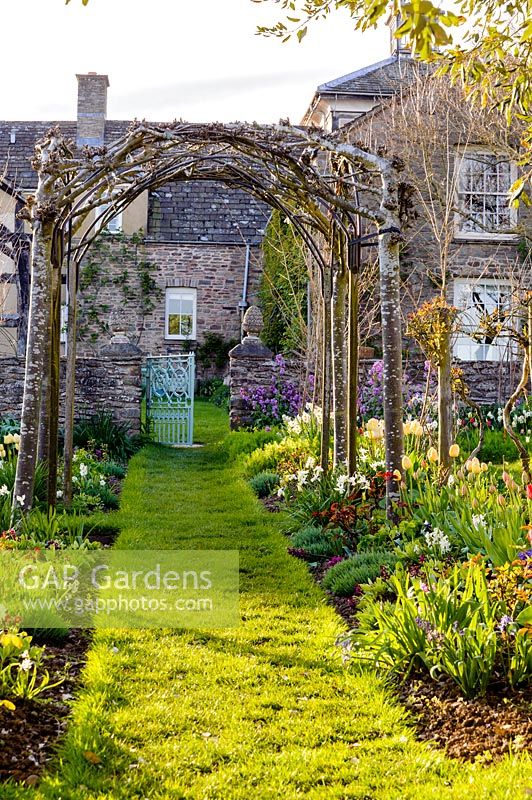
[331,264,347,467]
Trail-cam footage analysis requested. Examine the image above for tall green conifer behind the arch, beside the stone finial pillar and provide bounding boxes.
[259,211,308,353]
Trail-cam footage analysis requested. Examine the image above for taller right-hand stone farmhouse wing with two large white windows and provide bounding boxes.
[303,25,532,402]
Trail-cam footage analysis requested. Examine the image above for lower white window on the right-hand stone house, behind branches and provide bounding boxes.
[454,278,514,361]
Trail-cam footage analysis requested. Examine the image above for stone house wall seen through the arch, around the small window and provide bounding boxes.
[78,242,262,377]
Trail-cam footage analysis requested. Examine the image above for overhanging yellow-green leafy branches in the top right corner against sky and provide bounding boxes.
[260,0,532,189]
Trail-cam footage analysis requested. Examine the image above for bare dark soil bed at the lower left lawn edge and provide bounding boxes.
[0,630,90,784]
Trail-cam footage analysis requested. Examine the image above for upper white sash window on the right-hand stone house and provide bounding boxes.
[456,151,517,238]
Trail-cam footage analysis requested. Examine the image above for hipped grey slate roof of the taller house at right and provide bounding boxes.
[316,56,418,97]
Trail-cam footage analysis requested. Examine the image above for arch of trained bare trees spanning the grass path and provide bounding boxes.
[14,122,403,510]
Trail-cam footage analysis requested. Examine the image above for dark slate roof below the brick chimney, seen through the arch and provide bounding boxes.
[0,120,270,245]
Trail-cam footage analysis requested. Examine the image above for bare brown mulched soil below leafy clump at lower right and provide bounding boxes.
[304,564,532,764]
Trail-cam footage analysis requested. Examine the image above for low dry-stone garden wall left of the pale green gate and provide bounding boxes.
[0,355,142,433]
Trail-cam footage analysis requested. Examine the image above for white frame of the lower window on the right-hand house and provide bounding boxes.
[453,277,517,362]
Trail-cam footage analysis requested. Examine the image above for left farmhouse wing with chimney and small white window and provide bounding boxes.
[0,73,269,368]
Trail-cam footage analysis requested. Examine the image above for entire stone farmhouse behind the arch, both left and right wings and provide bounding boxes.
[0,20,530,400]
